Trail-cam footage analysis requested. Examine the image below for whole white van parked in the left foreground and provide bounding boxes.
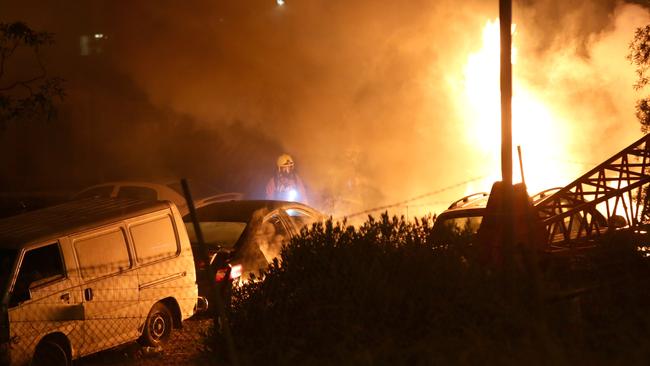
[0,199,197,365]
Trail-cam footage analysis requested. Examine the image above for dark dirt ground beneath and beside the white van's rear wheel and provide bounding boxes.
[75,318,212,366]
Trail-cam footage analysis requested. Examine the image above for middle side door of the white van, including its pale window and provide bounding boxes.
[72,226,140,354]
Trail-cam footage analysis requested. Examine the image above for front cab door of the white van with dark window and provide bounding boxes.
[9,241,83,359]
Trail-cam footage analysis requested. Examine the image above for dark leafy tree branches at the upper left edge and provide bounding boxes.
[0,22,64,127]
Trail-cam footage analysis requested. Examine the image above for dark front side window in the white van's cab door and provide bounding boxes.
[10,243,65,306]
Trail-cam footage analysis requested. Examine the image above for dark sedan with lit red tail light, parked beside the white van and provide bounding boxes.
[183,200,323,308]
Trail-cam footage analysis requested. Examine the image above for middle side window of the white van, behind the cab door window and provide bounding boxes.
[74,230,131,280]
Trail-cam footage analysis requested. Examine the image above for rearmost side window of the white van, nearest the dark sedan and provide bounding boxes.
[129,216,180,263]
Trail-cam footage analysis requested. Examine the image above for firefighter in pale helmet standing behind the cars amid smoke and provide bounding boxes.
[266,154,307,204]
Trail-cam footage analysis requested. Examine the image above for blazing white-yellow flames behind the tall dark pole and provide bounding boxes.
[462,19,576,194]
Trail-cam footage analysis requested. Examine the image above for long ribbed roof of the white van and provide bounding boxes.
[0,198,171,249]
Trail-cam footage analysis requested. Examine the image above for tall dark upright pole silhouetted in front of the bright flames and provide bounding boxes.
[499,0,512,187]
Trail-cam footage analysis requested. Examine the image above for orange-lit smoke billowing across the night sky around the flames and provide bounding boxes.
[0,0,650,214]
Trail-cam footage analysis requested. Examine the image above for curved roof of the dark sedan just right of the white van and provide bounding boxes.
[185,200,322,222]
